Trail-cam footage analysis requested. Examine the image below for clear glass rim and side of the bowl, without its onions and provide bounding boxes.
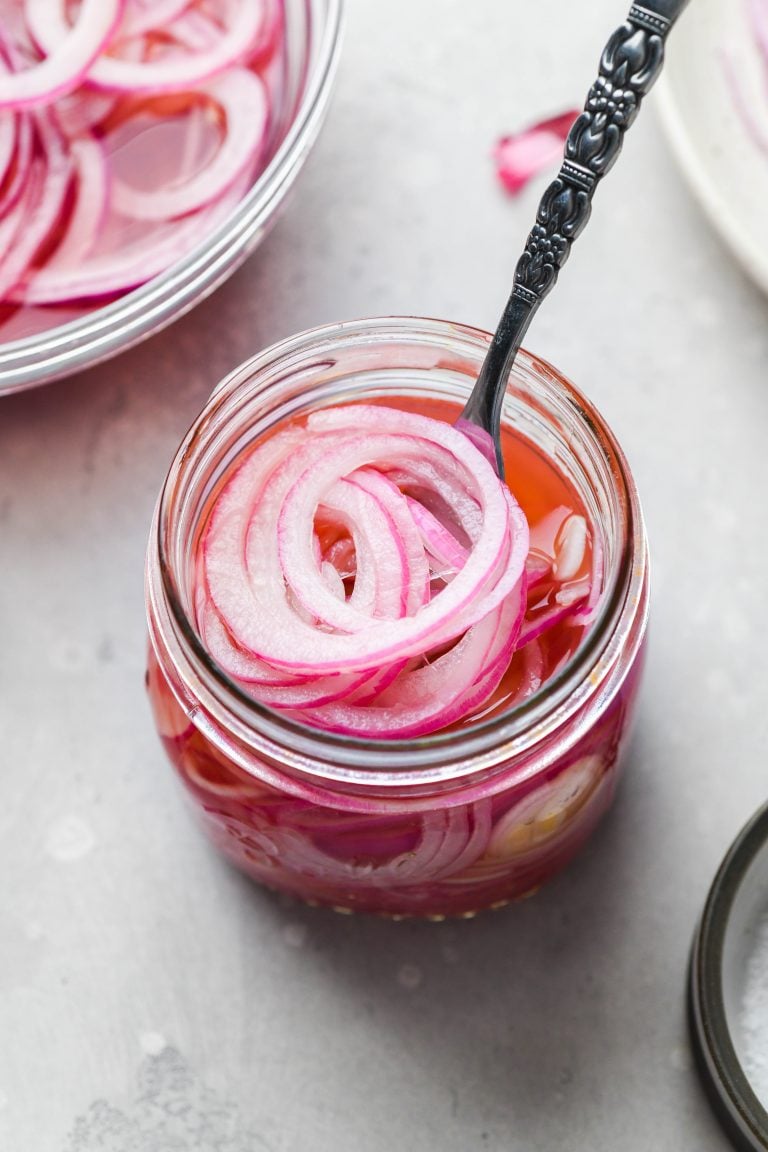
[0,0,342,396]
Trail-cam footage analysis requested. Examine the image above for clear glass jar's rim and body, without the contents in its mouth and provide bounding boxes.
[146,319,648,918]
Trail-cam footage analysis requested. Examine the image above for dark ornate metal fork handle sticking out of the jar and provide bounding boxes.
[462,0,687,475]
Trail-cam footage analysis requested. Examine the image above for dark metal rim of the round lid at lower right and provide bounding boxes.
[689,804,768,1152]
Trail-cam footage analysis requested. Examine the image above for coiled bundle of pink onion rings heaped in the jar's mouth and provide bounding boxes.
[196,404,545,738]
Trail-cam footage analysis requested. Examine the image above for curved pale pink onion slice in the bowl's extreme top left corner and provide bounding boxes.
[0,0,123,108]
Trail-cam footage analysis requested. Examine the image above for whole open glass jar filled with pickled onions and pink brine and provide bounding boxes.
[146,319,648,917]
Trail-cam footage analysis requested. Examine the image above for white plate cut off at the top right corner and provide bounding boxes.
[654,0,768,291]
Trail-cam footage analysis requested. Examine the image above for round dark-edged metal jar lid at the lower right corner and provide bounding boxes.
[689,805,768,1152]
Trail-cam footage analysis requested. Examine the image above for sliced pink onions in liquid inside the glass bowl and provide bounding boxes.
[0,0,282,305]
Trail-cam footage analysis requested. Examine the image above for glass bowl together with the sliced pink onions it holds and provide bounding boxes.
[0,0,341,394]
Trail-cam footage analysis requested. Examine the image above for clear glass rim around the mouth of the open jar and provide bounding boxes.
[151,317,647,786]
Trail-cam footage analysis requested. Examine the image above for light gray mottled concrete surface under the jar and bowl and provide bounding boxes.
[0,0,768,1152]
